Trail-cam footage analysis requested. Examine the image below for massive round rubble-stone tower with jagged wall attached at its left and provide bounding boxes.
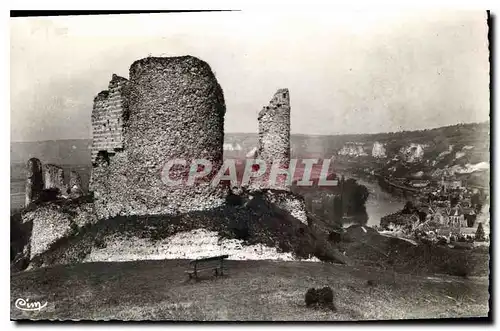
[90,56,226,217]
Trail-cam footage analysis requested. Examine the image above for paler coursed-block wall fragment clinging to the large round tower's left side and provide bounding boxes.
[91,74,128,162]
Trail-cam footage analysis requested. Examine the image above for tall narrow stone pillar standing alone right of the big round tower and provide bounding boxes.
[257,89,290,189]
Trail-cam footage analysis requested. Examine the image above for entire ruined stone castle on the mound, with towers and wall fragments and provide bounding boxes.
[18,56,308,268]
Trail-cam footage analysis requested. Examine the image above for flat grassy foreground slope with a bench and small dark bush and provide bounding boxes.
[11,260,489,321]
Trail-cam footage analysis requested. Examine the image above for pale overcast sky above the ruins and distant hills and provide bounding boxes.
[10,11,489,141]
